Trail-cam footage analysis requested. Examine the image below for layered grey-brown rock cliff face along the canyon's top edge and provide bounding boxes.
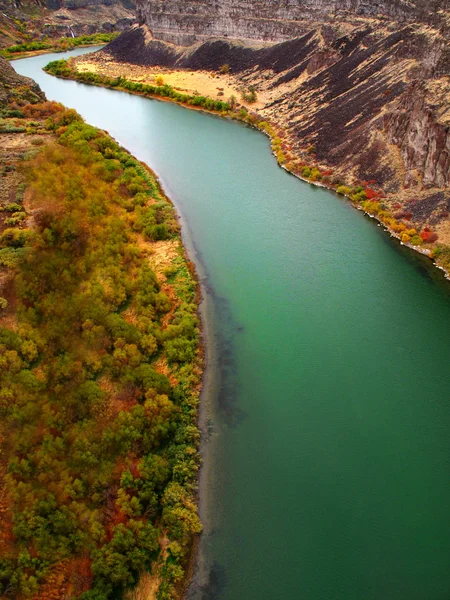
[135,0,450,45]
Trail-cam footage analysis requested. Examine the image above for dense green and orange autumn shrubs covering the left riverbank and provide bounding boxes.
[0,102,201,600]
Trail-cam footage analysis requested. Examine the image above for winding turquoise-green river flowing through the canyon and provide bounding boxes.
[14,50,450,600]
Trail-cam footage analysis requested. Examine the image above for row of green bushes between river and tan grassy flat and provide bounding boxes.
[44,60,230,112]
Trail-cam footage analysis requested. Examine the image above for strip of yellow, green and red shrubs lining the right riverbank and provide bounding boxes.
[45,56,450,278]
